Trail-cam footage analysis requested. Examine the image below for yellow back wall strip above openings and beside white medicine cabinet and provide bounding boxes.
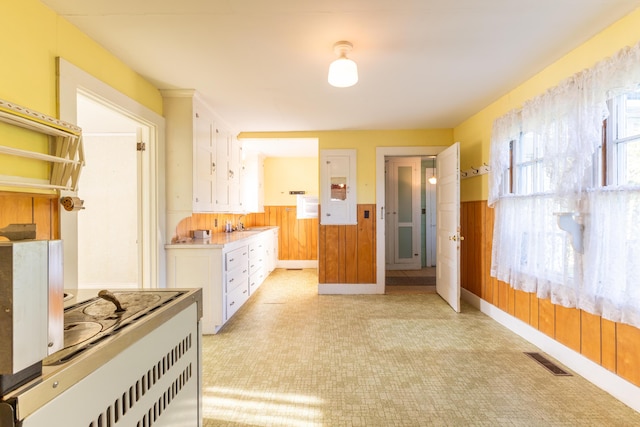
[240,129,454,204]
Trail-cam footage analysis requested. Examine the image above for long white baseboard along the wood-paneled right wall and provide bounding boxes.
[461,289,640,412]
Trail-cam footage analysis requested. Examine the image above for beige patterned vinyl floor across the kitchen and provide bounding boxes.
[202,270,640,427]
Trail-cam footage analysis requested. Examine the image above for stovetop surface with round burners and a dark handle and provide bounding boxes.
[42,291,184,366]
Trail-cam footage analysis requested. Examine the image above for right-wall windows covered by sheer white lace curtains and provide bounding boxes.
[487,43,640,327]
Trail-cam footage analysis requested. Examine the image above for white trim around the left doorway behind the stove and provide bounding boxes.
[57,58,166,289]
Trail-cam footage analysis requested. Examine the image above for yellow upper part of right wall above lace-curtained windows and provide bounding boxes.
[453,8,640,201]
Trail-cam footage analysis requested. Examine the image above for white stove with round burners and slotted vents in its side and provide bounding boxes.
[0,289,202,427]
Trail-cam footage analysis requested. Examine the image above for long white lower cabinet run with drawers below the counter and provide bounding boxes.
[165,228,278,334]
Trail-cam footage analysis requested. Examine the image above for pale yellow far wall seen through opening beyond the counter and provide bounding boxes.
[264,157,319,206]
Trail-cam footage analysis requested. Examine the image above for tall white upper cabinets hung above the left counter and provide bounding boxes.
[162,90,242,216]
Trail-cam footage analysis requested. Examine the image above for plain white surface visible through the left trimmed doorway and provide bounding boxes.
[76,95,141,288]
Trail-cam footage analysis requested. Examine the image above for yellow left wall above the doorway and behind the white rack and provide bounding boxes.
[0,0,162,189]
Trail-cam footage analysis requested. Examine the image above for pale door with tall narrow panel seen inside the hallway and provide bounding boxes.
[386,157,422,270]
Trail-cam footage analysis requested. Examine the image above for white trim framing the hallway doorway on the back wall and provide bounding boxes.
[375,145,447,294]
